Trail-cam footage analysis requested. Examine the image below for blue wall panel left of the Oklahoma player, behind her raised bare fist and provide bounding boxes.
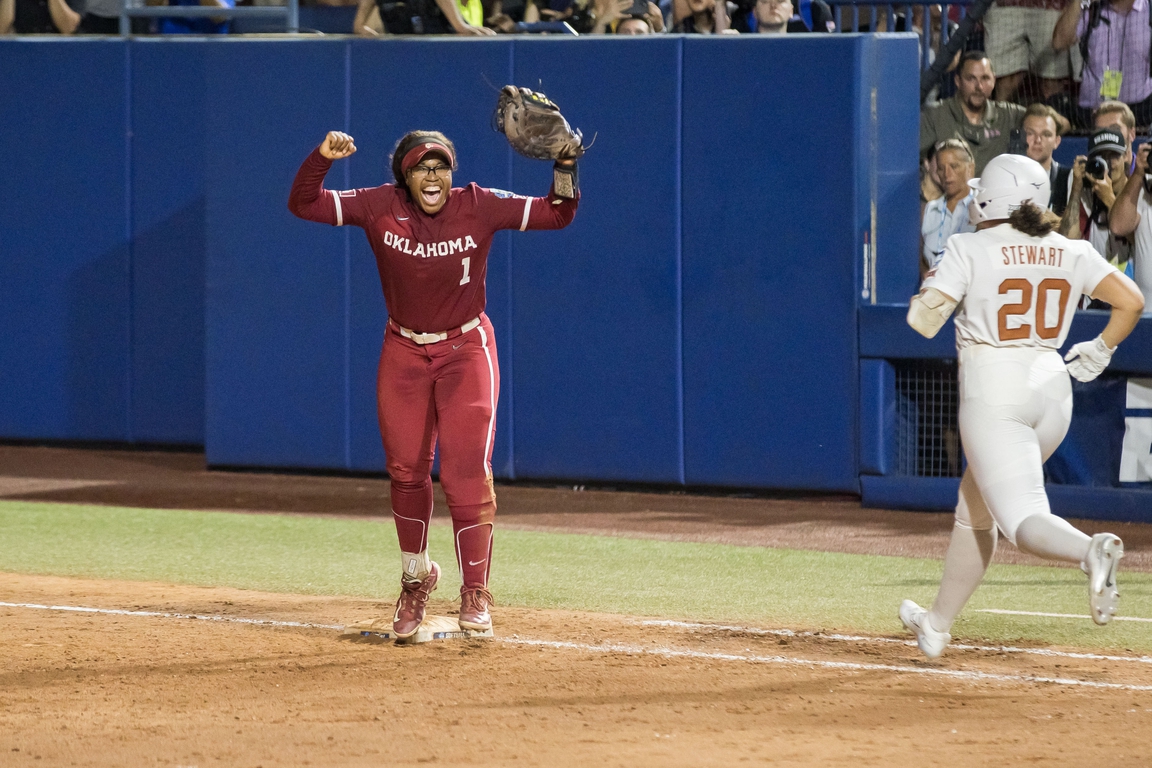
[204,40,347,467]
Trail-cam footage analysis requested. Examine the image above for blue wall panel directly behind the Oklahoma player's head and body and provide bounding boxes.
[343,39,511,477]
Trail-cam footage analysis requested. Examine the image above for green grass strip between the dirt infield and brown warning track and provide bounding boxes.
[0,502,1152,652]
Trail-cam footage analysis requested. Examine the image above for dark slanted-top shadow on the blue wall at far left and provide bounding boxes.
[60,197,205,444]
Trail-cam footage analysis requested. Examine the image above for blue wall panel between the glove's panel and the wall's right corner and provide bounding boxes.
[683,36,859,491]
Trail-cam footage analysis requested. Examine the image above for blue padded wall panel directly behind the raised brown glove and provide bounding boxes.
[511,38,683,482]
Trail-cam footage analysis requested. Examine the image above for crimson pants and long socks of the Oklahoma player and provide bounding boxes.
[377,314,500,587]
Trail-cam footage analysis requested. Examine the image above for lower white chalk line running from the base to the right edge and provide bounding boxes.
[500,638,1152,691]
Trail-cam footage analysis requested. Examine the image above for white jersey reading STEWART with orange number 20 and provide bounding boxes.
[924,223,1115,350]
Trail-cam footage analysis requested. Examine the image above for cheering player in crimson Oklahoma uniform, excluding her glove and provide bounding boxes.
[288,131,578,638]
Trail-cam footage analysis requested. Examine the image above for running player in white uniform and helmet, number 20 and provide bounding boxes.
[900,154,1144,659]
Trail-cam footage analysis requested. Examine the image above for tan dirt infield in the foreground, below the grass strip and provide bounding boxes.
[0,575,1152,768]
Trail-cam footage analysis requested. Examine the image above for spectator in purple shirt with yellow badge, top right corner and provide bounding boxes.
[1052,0,1152,127]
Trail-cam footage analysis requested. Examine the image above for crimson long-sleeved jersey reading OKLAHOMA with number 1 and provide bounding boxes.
[288,150,576,333]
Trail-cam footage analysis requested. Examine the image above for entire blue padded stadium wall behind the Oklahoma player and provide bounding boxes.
[0,35,918,492]
